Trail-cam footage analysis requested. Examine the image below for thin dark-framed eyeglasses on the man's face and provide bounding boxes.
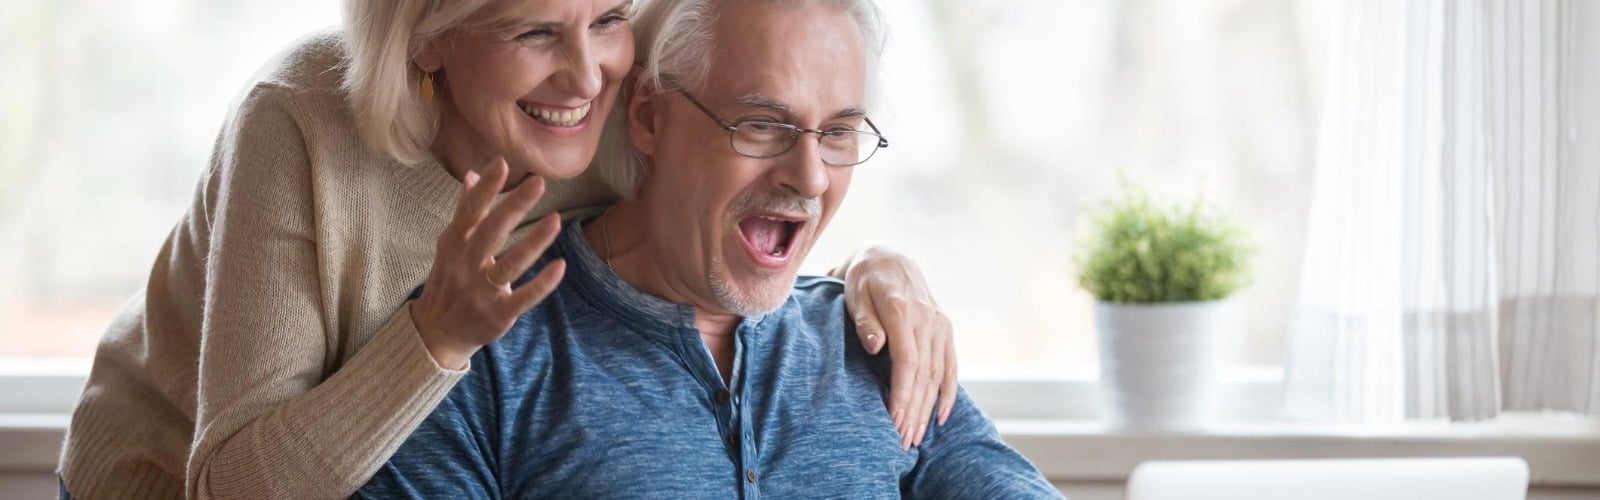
[678,88,890,167]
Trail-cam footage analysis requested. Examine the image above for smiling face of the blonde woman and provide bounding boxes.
[416,0,634,178]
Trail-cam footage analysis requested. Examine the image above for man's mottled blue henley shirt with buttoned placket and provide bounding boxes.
[357,213,1059,498]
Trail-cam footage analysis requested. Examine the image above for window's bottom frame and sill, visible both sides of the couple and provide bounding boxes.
[0,372,1600,487]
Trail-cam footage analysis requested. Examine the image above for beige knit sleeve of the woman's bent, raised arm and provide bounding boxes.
[187,85,464,498]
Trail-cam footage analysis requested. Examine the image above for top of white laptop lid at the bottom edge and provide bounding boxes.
[1128,457,1528,500]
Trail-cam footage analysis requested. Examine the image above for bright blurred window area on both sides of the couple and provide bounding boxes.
[0,0,1330,377]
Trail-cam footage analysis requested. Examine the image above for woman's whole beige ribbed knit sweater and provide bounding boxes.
[61,34,610,498]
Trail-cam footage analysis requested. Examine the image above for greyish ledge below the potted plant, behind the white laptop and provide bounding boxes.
[995,417,1600,487]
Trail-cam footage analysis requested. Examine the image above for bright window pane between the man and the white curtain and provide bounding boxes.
[812,0,1328,377]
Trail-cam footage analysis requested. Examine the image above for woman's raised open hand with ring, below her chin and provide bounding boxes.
[411,160,566,370]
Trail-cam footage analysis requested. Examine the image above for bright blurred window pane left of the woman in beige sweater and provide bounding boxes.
[0,0,339,365]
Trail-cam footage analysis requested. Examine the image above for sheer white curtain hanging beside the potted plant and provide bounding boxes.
[1285,0,1600,423]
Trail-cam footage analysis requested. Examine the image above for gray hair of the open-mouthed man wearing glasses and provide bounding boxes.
[590,0,886,199]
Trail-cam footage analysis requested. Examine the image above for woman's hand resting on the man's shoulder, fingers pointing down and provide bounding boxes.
[830,245,955,449]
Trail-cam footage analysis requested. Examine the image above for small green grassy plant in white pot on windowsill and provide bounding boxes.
[1077,189,1250,431]
